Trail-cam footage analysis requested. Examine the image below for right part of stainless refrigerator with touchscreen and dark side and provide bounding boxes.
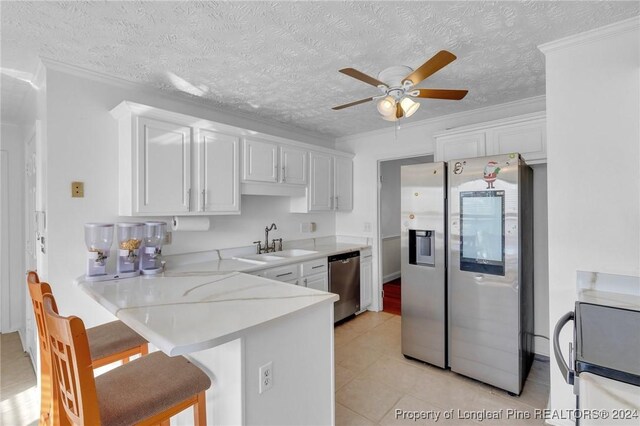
[448,154,533,394]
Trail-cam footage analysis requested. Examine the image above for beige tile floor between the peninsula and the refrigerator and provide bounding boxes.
[335,312,549,426]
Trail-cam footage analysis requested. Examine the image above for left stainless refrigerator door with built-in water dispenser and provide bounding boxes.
[400,163,447,368]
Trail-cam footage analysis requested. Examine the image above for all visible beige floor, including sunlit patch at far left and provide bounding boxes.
[0,312,549,426]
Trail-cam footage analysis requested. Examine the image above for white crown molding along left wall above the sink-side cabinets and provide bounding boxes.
[40,57,334,146]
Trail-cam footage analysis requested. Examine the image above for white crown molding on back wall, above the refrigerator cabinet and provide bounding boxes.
[336,95,546,147]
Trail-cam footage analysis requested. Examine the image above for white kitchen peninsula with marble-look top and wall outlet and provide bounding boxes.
[77,272,338,426]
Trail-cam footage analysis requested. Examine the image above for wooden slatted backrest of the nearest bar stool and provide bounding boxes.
[43,294,100,425]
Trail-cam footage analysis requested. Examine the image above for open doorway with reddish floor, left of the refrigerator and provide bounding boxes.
[378,155,433,315]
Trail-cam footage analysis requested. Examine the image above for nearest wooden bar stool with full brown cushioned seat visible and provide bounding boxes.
[43,294,211,426]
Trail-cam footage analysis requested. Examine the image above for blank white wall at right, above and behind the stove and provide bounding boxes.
[541,18,640,424]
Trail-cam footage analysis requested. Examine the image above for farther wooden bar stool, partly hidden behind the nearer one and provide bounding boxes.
[27,271,149,425]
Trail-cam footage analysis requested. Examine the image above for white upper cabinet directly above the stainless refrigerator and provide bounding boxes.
[435,112,547,164]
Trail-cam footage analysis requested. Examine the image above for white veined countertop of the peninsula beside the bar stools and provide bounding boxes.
[76,272,338,356]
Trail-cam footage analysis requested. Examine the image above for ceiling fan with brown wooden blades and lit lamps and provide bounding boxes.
[332,50,468,121]
